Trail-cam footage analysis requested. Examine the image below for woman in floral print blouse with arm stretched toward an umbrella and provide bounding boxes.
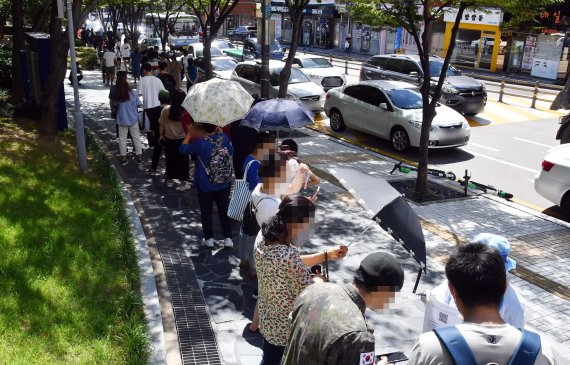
[254,195,348,365]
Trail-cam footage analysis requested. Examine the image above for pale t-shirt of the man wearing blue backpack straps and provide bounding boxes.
[408,323,556,365]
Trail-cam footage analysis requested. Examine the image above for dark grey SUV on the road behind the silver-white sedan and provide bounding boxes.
[360,55,487,115]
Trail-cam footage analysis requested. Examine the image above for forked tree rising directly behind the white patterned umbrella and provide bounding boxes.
[185,0,239,80]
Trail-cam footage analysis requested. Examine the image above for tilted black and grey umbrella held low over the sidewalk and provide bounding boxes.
[330,168,427,293]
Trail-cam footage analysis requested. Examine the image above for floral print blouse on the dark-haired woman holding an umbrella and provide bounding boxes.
[254,232,313,346]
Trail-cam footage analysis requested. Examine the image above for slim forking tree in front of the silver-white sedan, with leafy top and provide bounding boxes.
[348,0,555,197]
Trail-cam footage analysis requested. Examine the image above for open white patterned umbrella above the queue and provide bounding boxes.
[182,78,253,127]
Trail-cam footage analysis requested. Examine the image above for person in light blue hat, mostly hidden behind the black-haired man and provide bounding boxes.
[429,233,528,328]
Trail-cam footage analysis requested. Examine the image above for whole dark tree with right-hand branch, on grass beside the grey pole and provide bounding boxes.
[39,0,99,140]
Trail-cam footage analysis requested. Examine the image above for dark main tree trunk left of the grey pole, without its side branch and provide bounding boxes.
[39,1,69,140]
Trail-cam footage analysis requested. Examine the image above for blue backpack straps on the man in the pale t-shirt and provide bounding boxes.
[433,326,541,365]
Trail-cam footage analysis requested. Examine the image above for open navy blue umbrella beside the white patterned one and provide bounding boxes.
[240,99,315,132]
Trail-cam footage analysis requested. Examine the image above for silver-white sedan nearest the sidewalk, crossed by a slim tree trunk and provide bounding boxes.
[325,80,471,152]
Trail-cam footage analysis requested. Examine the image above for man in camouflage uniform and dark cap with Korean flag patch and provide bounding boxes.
[283,252,404,365]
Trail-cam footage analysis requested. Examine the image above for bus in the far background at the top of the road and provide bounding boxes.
[144,12,200,38]
